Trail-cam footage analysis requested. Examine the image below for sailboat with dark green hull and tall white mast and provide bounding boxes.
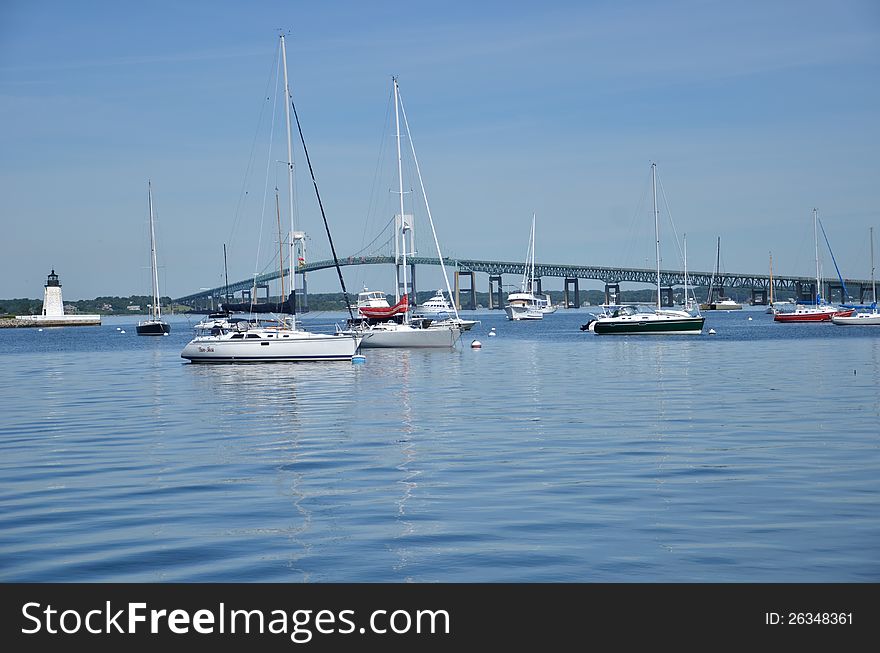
[581,163,706,335]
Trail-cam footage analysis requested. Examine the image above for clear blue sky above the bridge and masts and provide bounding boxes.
[0,0,880,299]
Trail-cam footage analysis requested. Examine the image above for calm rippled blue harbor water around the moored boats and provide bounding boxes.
[0,310,880,582]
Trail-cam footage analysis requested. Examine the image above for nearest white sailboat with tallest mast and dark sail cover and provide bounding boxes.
[180,35,361,363]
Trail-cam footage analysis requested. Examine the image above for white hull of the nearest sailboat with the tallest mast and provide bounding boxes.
[180,331,360,363]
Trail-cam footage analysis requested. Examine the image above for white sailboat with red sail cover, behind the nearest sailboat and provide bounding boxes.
[341,77,464,348]
